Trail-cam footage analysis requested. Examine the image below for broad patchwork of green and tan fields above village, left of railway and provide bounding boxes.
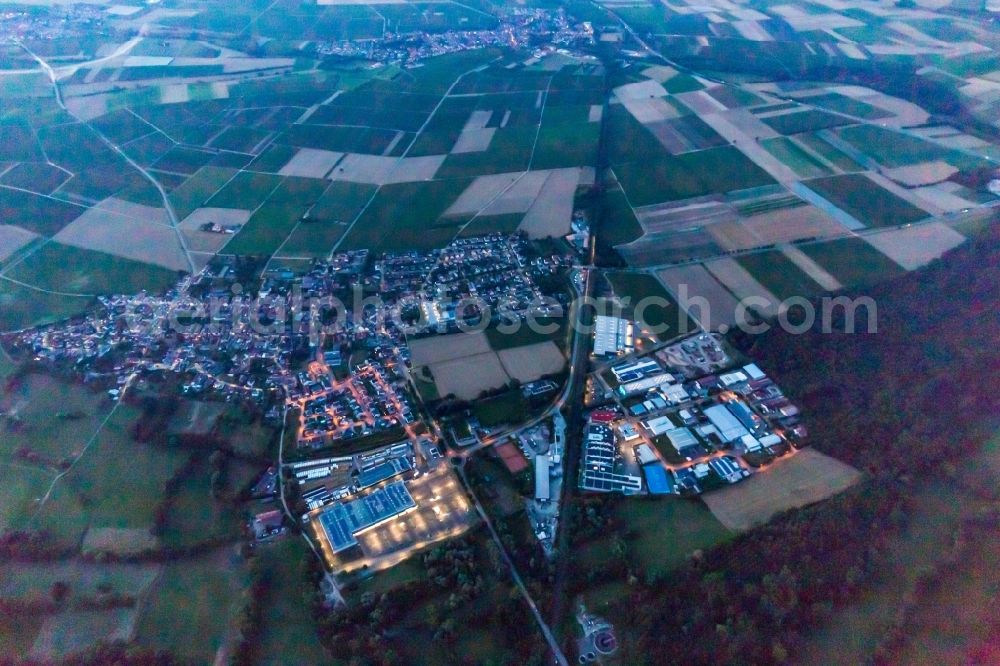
[0,42,603,328]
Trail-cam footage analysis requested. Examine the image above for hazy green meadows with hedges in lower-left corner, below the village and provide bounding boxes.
[0,374,258,662]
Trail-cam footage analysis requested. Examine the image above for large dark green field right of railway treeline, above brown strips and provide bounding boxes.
[615,146,774,207]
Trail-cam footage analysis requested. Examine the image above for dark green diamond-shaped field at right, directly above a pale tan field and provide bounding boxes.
[806,174,928,227]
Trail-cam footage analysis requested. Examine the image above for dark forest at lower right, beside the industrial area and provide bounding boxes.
[577,228,1000,664]
